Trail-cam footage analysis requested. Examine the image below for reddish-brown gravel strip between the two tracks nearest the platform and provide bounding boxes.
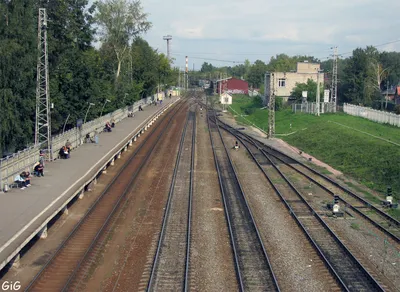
[81,101,186,291]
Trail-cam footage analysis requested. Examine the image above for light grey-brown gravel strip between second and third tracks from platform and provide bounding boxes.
[190,110,238,291]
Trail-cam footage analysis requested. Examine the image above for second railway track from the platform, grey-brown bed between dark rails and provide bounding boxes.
[147,104,196,291]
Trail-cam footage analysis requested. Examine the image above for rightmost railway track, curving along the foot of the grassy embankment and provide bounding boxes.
[220,117,400,244]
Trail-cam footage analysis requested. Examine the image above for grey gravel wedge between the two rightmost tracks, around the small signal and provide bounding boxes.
[266,148,400,290]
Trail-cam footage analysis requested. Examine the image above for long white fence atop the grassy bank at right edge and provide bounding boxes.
[343,103,400,127]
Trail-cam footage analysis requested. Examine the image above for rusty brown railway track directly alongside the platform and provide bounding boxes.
[25,101,185,291]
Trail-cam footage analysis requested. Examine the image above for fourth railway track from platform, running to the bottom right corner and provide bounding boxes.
[215,116,384,291]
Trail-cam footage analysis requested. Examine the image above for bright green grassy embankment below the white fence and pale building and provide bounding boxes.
[230,96,400,218]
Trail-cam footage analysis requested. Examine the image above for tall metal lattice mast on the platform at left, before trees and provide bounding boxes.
[35,8,52,160]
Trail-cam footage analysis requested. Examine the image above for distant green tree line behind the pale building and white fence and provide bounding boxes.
[200,46,400,108]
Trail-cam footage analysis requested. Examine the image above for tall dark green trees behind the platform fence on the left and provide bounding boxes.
[0,0,178,155]
